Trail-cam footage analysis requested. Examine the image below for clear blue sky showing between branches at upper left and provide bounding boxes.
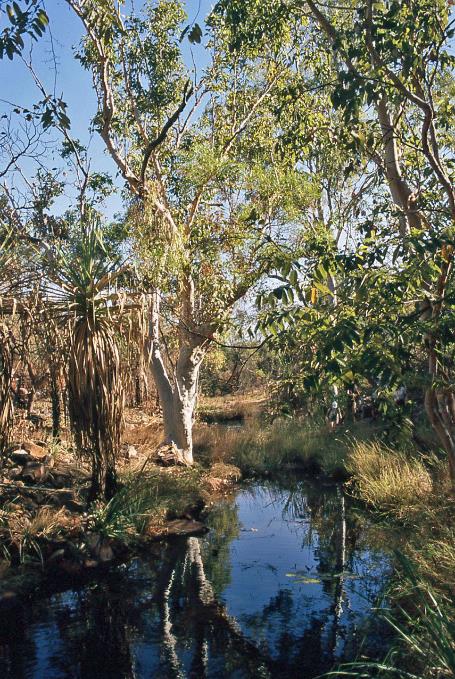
[0,0,213,217]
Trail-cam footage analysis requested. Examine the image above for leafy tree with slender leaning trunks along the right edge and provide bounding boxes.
[215,0,455,488]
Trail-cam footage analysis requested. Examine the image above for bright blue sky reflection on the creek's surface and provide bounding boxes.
[213,489,392,664]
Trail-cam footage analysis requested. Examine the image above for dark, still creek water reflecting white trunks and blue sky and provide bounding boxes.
[0,481,391,679]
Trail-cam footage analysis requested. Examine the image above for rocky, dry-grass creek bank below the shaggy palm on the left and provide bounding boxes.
[0,442,240,596]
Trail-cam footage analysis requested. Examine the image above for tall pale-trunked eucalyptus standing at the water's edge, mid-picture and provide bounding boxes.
[67,0,311,464]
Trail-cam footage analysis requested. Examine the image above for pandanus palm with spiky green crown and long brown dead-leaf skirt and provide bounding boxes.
[47,222,129,499]
